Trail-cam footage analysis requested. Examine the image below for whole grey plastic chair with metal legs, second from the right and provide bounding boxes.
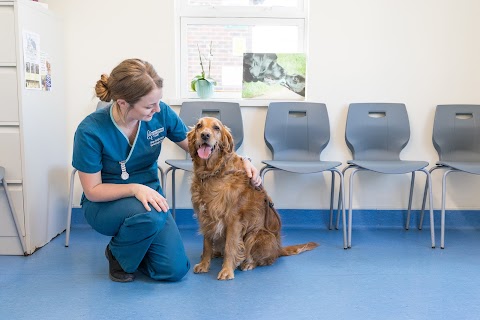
[343,103,435,248]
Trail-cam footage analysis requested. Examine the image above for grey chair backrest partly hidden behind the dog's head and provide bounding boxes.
[179,101,243,150]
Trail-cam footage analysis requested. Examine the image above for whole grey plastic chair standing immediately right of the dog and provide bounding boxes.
[260,102,347,249]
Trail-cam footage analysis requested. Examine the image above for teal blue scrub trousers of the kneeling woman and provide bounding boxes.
[82,197,190,281]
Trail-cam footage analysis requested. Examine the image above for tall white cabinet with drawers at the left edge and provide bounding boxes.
[0,0,70,255]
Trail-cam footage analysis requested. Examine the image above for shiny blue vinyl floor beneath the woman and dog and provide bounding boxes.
[0,210,480,320]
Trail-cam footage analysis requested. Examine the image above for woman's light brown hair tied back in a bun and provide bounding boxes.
[95,59,163,106]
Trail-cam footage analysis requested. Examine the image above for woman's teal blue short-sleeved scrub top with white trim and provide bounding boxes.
[72,102,188,202]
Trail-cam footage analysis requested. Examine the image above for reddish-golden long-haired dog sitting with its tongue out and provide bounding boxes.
[187,117,318,280]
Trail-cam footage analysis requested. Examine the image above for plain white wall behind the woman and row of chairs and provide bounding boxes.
[47,0,480,209]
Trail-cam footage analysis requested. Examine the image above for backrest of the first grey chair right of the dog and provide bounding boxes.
[264,102,330,161]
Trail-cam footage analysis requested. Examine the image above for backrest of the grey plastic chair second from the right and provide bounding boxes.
[345,103,410,160]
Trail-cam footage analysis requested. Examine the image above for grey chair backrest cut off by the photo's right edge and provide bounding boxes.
[432,104,480,162]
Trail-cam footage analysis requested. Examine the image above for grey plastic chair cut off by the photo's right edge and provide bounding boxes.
[420,104,480,249]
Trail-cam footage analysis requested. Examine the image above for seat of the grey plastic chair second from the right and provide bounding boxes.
[347,160,428,174]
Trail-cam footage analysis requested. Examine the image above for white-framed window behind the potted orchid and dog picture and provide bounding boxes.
[177,0,307,99]
